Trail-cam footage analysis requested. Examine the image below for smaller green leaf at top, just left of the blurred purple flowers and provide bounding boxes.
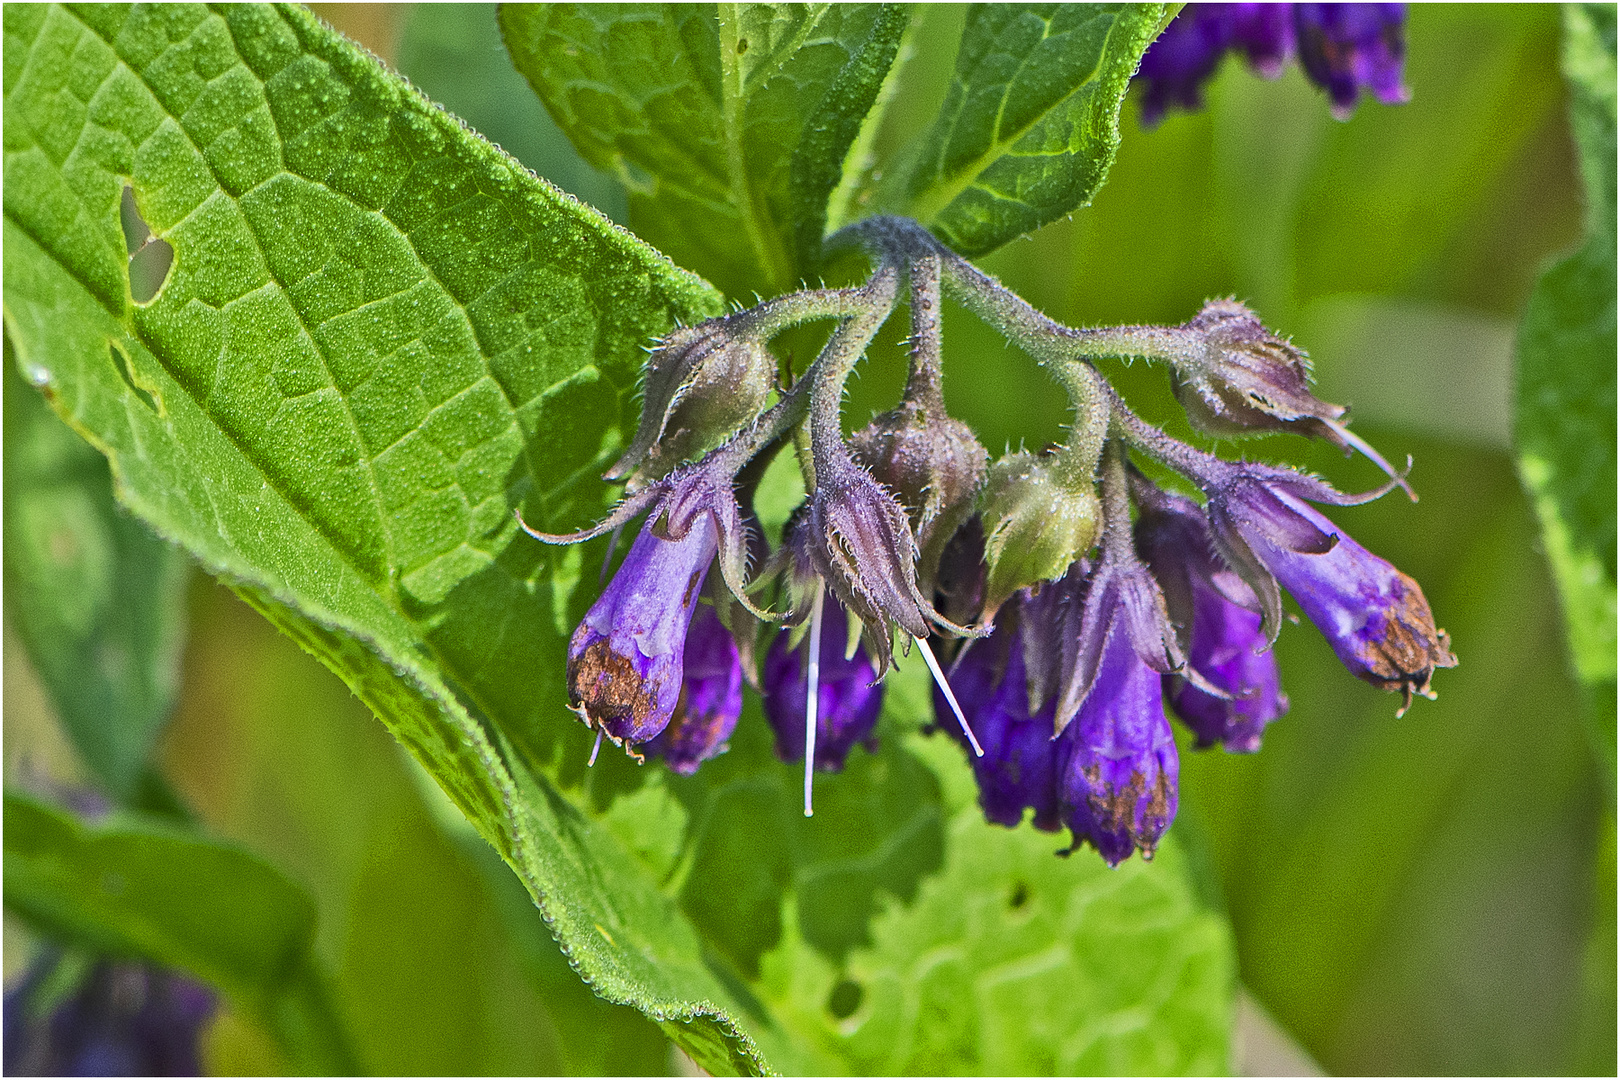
[888,3,1168,256]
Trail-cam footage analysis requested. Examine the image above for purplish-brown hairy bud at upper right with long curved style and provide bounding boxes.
[1176,300,1345,445]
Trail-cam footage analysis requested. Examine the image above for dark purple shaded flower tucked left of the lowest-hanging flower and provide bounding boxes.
[933,605,1063,832]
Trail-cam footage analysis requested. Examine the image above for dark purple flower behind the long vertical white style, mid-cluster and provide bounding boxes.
[760,594,883,772]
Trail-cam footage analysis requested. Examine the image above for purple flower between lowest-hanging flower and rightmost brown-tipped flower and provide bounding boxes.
[1132,478,1288,753]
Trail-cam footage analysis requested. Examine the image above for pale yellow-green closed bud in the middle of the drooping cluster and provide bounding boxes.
[982,452,1102,617]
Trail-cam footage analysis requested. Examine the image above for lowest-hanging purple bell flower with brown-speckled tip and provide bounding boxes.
[1058,627,1179,866]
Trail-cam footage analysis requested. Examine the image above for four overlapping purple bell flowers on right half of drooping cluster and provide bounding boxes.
[935,449,1456,865]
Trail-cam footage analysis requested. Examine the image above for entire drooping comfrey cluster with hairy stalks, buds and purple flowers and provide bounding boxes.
[525,217,1456,863]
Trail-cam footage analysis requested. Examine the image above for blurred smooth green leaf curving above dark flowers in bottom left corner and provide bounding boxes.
[5,792,355,1074]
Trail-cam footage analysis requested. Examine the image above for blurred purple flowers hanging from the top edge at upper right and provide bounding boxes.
[1136,3,1411,126]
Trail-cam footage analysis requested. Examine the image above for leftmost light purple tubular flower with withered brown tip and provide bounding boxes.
[569,512,719,745]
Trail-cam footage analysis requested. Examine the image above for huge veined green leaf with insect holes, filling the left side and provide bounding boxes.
[5,6,780,1069]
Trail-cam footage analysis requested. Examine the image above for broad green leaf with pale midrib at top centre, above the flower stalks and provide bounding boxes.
[501,3,910,298]
